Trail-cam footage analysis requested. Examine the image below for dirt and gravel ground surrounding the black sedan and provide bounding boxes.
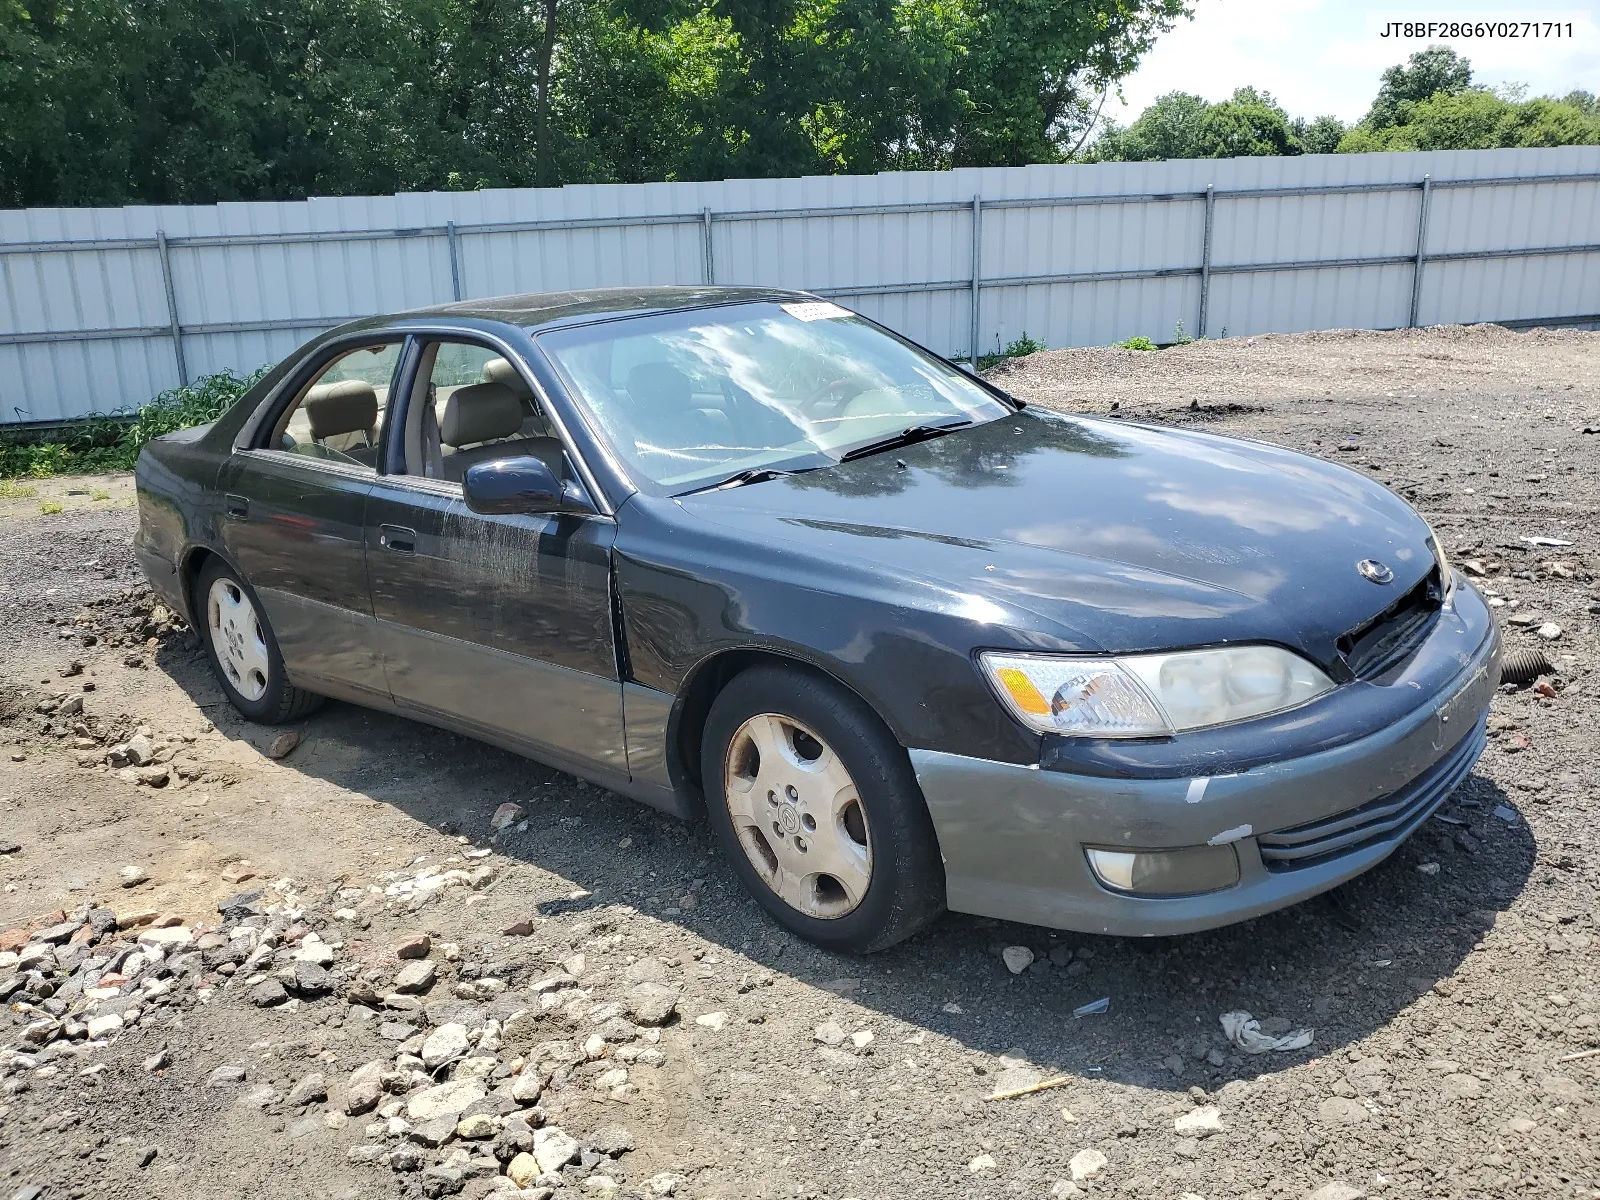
[0,328,1600,1200]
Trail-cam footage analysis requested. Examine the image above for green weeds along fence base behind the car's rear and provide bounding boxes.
[0,366,267,480]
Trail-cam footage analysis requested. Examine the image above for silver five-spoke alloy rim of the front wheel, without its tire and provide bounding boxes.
[723,712,872,918]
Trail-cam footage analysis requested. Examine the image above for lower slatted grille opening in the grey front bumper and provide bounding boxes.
[1256,722,1488,870]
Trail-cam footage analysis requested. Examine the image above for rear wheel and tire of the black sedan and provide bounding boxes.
[194,558,322,725]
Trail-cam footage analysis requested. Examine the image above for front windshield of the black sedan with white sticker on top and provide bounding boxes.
[539,301,1010,494]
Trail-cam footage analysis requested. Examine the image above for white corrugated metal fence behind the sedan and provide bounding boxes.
[0,147,1600,422]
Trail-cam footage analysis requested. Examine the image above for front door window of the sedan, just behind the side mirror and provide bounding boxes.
[406,341,563,483]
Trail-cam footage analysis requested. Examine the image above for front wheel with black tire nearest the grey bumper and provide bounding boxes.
[701,667,944,954]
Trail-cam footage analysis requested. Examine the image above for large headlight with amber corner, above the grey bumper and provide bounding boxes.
[979,646,1333,738]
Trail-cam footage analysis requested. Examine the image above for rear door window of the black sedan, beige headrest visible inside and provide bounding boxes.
[270,342,400,470]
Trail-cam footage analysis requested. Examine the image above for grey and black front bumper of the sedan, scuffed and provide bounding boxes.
[910,587,1499,936]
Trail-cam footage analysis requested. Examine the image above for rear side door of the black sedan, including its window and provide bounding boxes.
[218,338,403,704]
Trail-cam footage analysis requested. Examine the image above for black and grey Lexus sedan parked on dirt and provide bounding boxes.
[136,288,1499,950]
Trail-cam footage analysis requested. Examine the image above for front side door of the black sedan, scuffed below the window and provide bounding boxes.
[365,342,627,779]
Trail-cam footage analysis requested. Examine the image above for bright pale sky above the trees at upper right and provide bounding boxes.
[1106,0,1600,125]
